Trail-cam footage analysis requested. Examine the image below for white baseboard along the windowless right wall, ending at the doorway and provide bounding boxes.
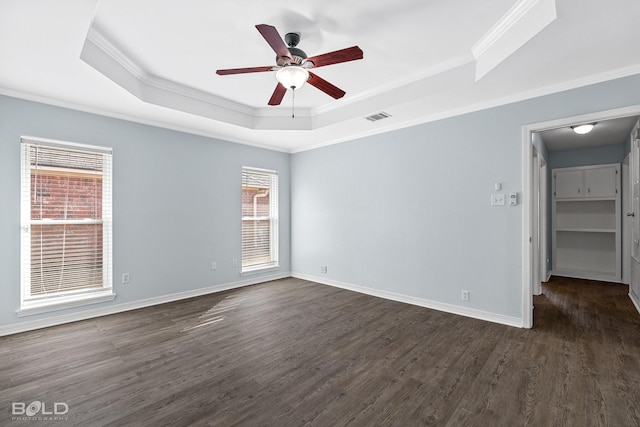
[291,273,524,328]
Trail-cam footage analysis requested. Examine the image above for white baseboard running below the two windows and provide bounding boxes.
[0,271,291,336]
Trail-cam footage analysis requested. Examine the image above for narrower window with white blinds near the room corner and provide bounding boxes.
[242,167,278,272]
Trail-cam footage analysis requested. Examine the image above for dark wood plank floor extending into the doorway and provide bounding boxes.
[0,279,640,427]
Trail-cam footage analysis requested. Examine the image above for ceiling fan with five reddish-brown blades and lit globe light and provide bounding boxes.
[216,24,363,105]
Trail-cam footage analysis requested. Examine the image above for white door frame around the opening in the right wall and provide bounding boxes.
[521,105,640,328]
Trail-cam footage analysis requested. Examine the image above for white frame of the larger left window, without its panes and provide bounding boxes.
[16,136,115,316]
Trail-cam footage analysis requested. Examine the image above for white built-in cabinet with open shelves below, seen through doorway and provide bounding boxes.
[552,164,622,282]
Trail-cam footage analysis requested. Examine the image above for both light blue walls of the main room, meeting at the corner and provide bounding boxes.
[0,72,640,332]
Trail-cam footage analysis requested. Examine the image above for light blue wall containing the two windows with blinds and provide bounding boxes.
[0,96,291,332]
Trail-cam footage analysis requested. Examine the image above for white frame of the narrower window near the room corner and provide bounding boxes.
[241,166,280,274]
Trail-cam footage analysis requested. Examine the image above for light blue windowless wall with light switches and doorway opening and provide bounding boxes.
[291,75,640,318]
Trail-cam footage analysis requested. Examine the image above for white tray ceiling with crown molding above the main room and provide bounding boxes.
[0,0,640,152]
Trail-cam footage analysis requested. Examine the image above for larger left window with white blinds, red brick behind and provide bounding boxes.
[18,138,114,315]
